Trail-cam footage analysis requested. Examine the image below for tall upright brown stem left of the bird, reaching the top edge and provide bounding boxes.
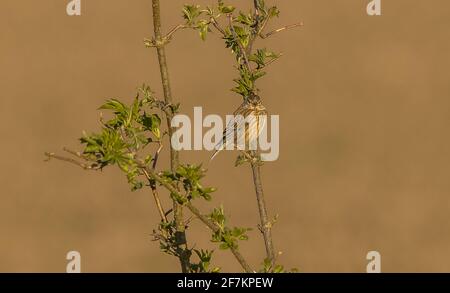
[152,0,190,273]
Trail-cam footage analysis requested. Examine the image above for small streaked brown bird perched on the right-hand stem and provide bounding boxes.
[211,93,267,160]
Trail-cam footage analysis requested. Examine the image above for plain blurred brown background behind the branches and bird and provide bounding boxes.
[0,0,450,272]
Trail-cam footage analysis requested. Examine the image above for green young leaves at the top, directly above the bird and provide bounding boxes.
[183,0,280,98]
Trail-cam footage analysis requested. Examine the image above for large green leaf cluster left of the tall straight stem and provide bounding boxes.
[80,91,162,191]
